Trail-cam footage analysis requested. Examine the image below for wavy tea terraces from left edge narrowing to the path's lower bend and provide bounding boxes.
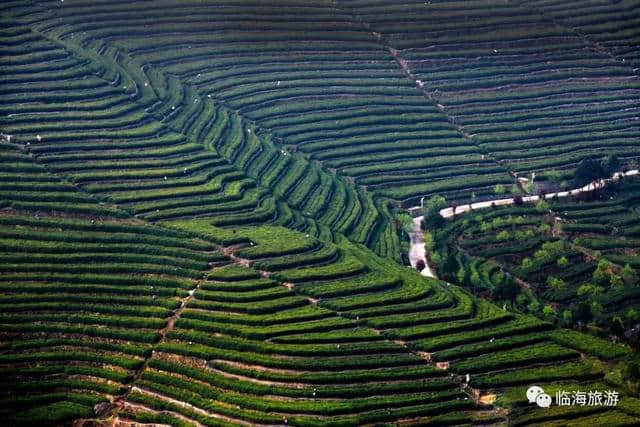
[1,11,400,259]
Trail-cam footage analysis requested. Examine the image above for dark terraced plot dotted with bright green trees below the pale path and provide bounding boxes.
[433,178,640,342]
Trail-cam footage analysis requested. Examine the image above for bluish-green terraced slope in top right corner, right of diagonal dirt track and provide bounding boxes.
[341,0,640,187]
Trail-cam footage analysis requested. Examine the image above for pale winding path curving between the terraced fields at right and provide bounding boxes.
[409,169,640,278]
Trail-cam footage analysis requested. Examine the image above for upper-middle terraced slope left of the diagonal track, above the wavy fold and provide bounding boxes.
[13,1,510,209]
